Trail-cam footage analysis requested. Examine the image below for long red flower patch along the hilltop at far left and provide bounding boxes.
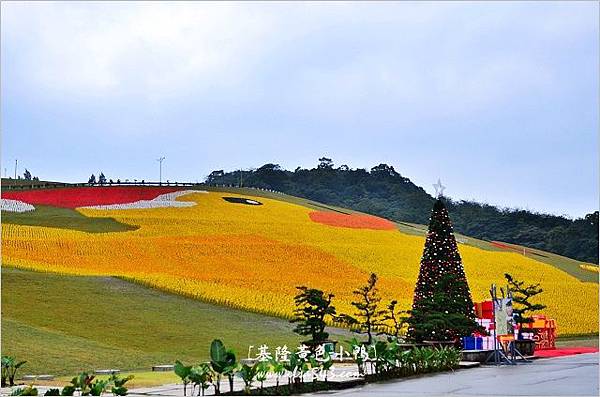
[2,186,181,208]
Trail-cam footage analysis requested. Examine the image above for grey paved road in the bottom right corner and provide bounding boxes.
[327,353,599,396]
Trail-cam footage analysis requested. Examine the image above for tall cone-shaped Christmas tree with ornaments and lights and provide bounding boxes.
[408,198,480,342]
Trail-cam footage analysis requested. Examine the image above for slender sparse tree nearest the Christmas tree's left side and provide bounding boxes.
[343,273,385,345]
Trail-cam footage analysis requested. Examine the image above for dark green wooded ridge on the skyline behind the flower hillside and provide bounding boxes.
[206,158,598,263]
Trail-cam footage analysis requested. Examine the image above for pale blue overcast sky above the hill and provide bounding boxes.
[1,2,599,216]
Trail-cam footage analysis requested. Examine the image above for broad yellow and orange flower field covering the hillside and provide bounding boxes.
[2,192,598,334]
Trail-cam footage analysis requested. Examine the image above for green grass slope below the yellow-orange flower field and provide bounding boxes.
[2,267,354,375]
